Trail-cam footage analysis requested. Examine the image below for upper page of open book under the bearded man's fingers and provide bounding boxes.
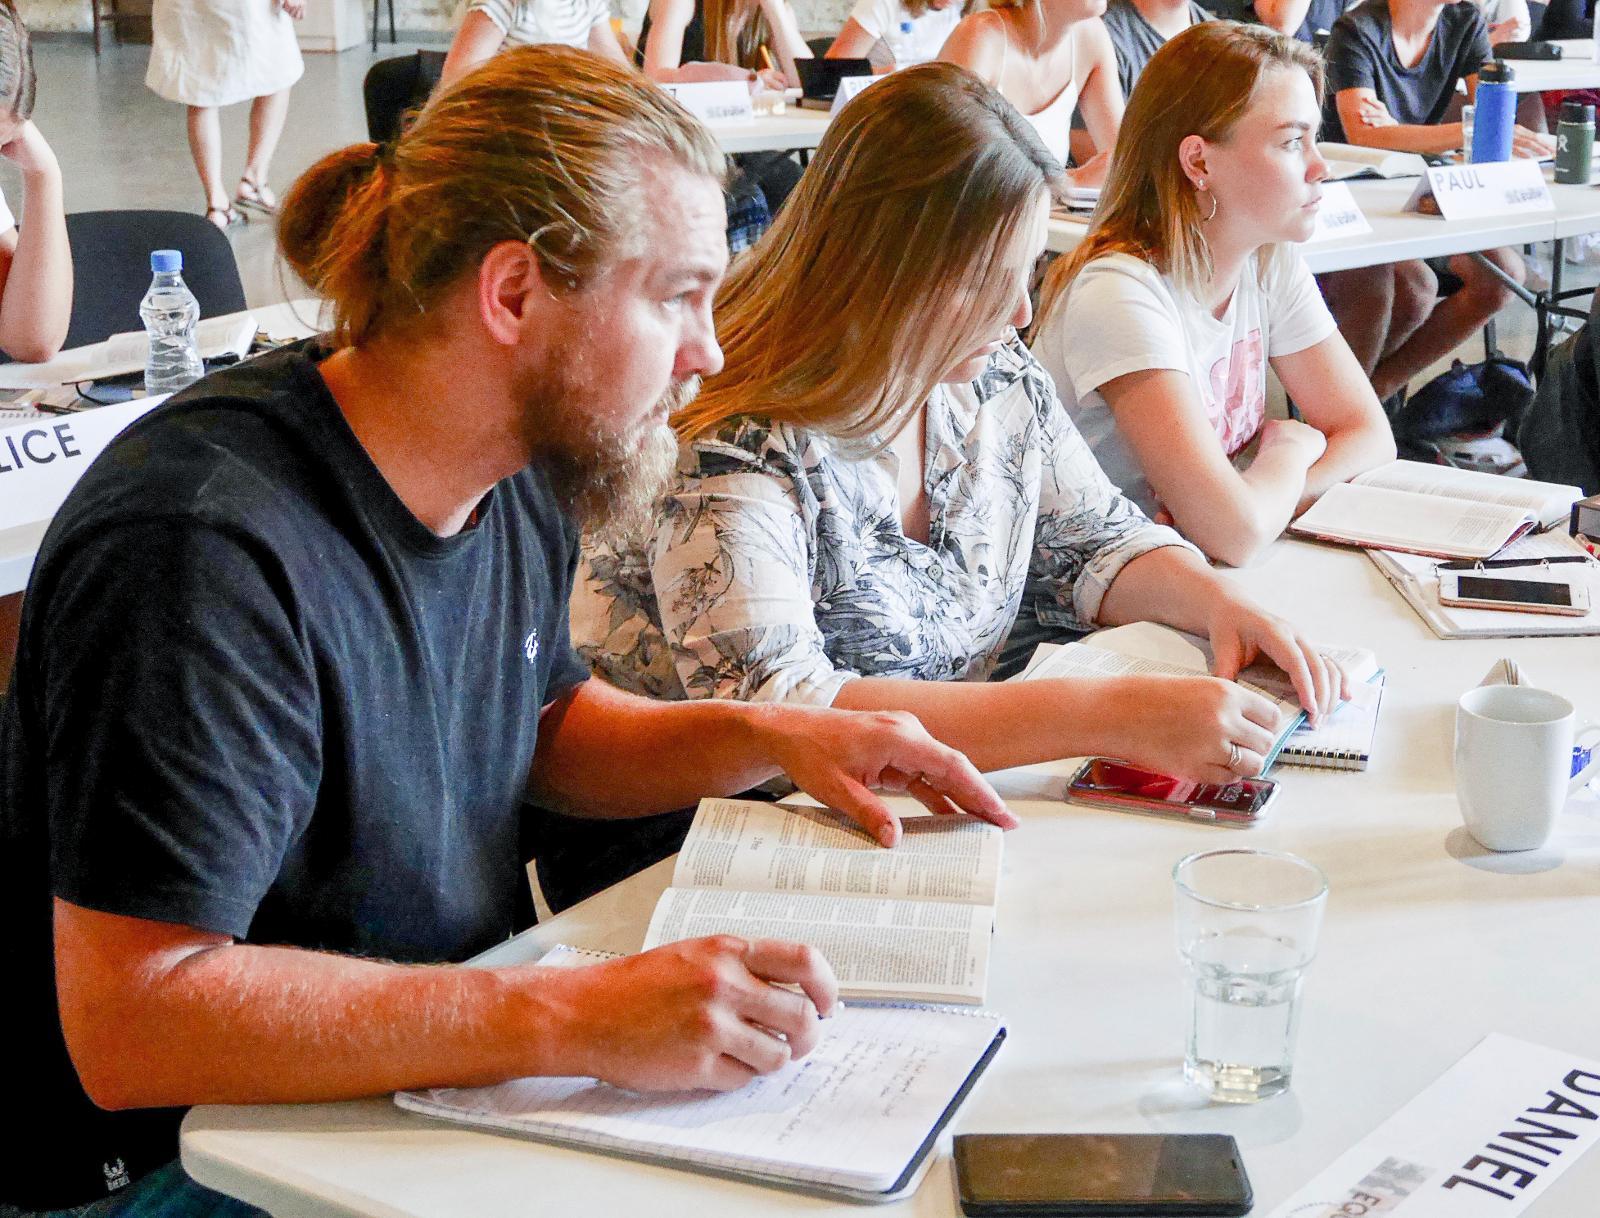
[672,799,1003,904]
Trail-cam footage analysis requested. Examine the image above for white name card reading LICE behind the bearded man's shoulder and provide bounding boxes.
[0,394,166,530]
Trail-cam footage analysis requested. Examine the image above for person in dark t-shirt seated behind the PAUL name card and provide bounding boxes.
[1320,0,1554,399]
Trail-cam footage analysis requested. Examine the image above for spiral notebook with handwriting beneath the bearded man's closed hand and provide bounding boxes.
[395,948,1005,1200]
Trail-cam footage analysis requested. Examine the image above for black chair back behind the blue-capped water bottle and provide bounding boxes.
[66,211,245,347]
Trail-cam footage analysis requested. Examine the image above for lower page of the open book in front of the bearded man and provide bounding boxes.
[645,888,994,1002]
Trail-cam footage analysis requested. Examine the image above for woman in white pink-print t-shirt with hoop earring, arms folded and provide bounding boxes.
[1034,21,1395,565]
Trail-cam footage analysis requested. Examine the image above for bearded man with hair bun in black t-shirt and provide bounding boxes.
[0,46,1014,1218]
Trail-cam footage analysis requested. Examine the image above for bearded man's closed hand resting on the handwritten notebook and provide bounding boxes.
[560,935,838,1092]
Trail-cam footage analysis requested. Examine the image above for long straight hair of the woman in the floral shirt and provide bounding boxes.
[674,64,1062,443]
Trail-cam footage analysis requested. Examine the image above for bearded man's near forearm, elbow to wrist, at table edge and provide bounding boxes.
[56,901,587,1109]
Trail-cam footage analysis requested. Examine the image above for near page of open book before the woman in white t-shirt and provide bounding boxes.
[1290,482,1534,559]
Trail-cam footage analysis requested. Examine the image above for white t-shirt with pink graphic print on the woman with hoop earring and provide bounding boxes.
[1034,248,1336,514]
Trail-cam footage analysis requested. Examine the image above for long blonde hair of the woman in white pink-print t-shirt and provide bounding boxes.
[1038,21,1323,325]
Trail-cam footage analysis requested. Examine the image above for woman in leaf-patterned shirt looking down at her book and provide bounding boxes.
[573,64,1342,797]
